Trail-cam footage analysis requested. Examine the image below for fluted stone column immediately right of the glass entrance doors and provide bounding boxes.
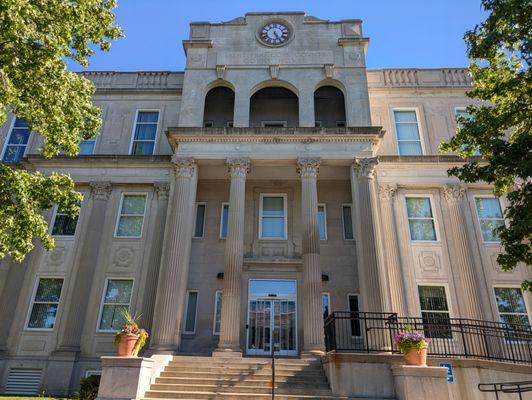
[297,158,325,354]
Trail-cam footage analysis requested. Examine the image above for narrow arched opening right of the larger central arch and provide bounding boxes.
[314,84,347,128]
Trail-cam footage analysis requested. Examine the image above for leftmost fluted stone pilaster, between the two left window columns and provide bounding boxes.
[57,182,111,352]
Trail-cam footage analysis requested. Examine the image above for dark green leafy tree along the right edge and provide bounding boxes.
[441,0,532,291]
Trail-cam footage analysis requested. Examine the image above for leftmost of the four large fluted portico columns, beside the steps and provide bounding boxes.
[150,155,198,351]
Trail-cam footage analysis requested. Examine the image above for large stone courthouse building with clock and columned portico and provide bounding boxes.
[0,12,532,398]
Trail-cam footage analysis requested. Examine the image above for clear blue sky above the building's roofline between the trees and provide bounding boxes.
[69,0,486,71]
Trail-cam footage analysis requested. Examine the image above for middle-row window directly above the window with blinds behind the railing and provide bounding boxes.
[406,197,436,241]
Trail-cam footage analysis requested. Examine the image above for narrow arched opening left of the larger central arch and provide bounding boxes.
[203,85,235,128]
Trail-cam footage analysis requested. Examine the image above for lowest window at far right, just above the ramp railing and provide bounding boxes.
[495,287,530,330]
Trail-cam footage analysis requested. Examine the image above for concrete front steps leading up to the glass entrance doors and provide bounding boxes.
[141,356,358,400]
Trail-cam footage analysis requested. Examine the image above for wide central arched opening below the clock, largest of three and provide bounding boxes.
[249,84,299,127]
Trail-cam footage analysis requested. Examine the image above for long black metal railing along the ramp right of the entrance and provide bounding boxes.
[324,311,532,364]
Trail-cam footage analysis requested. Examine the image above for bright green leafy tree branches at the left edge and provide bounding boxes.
[0,0,122,261]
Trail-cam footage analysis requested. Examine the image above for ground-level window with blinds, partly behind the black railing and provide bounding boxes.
[418,286,452,339]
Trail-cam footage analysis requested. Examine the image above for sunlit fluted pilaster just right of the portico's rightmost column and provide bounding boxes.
[379,185,408,317]
